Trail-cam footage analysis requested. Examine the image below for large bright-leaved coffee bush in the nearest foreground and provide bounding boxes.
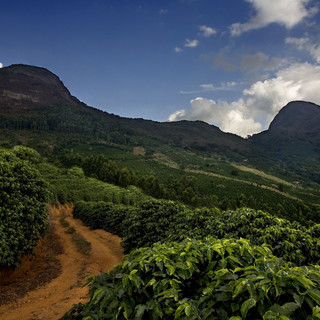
[63,238,320,320]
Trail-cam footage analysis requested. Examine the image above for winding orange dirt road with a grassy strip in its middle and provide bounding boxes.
[0,206,122,320]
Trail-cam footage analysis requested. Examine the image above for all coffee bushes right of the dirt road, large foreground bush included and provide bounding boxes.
[63,200,320,320]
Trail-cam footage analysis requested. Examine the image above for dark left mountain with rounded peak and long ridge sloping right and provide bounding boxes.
[0,65,248,153]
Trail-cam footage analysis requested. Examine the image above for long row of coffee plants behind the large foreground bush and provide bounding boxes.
[74,200,320,265]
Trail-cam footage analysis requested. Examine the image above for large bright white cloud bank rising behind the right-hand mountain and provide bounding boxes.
[168,63,320,136]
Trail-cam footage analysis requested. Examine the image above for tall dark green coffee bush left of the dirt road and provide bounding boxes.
[0,148,48,268]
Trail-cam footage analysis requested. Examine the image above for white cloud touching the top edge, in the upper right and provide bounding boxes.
[230,0,317,36]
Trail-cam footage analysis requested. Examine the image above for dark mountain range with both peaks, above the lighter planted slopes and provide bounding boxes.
[0,64,320,183]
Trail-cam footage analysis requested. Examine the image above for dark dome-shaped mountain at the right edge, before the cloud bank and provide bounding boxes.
[250,101,320,183]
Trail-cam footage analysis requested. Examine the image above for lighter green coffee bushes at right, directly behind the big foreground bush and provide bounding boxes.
[202,208,320,265]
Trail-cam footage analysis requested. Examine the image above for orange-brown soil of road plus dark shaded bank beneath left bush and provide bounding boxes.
[0,205,123,320]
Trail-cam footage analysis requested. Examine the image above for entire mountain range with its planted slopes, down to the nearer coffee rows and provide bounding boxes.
[0,65,320,216]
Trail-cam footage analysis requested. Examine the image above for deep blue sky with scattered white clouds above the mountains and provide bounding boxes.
[0,0,320,137]
